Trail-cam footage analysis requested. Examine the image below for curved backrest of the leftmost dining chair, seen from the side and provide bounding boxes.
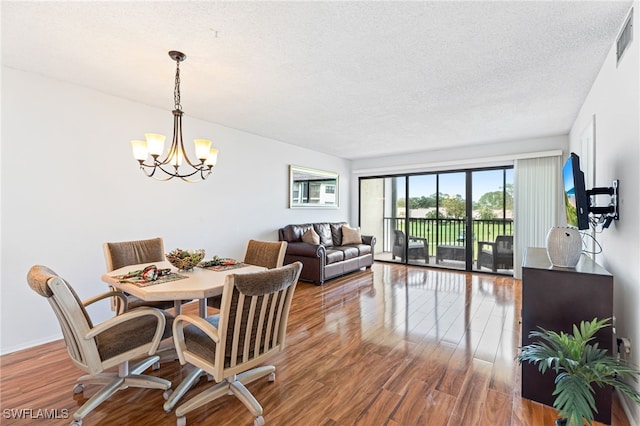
[27,265,102,374]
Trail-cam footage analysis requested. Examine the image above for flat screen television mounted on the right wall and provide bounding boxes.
[562,152,589,229]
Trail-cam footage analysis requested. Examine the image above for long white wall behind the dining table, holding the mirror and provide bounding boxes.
[0,67,350,354]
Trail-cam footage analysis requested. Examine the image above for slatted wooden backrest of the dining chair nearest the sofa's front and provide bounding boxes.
[214,262,302,377]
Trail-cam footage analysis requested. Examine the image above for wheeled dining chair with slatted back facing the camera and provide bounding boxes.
[164,262,302,426]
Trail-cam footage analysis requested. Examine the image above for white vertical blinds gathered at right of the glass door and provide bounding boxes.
[513,156,566,278]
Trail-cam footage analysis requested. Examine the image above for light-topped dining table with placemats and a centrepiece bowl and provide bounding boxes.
[102,260,267,317]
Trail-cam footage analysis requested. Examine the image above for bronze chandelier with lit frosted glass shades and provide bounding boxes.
[131,50,218,182]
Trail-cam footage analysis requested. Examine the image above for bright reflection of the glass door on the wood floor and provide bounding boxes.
[350,264,518,370]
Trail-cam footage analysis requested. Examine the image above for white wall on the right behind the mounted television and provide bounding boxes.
[570,1,640,424]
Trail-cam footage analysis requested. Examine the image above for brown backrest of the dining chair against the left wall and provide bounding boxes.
[104,238,164,272]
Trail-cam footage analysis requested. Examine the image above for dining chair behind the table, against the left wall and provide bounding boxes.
[103,238,174,311]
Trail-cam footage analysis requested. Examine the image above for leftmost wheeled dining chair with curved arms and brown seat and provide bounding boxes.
[27,265,171,426]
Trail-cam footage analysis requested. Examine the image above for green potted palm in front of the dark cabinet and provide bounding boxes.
[518,318,640,426]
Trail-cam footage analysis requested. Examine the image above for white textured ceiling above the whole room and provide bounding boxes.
[2,0,632,159]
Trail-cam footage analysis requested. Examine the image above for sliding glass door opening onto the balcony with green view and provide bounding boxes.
[360,168,513,274]
